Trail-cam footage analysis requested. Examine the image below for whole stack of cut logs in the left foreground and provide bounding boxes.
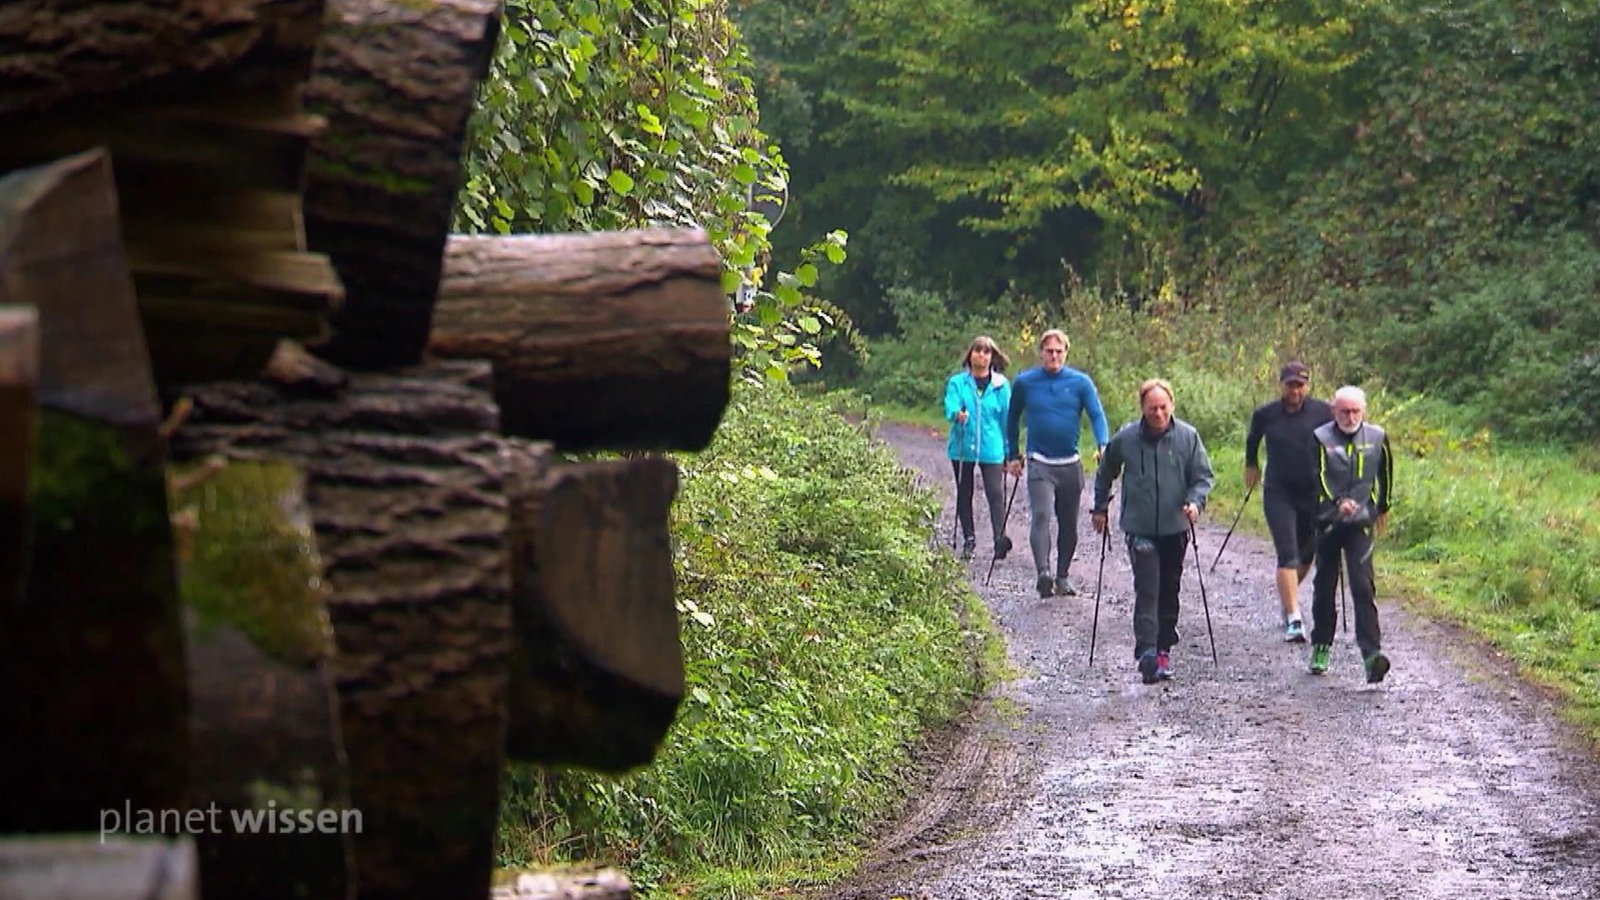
[0,0,730,900]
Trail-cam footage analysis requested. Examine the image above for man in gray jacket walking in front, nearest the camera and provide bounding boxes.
[1091,378,1211,684]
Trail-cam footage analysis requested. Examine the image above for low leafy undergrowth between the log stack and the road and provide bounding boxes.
[501,379,981,889]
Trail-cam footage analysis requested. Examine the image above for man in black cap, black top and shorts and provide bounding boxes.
[1245,362,1333,644]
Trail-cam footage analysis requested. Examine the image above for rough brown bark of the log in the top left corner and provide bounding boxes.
[0,0,323,117]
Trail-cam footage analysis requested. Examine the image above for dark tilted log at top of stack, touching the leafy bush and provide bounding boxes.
[306,0,501,368]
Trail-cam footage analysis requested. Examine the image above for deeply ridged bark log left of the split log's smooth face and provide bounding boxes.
[173,364,510,900]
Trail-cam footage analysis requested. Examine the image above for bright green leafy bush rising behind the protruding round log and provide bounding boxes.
[458,0,853,380]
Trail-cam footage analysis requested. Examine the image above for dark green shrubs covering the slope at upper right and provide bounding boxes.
[1216,0,1600,439]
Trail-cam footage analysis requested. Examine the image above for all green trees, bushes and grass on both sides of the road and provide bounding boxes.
[459,0,1600,897]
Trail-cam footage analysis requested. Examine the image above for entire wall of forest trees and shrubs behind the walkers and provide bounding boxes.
[734,0,1600,442]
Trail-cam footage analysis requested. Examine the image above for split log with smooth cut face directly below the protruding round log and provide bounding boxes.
[507,448,683,772]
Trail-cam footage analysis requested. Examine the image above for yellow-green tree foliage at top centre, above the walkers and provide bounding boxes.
[738,0,1366,325]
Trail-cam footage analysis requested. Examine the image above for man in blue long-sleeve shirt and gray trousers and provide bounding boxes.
[1005,328,1110,597]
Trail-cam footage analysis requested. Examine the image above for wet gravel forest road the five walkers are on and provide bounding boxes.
[819,426,1600,900]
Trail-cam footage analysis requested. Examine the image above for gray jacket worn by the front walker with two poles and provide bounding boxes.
[1094,416,1213,538]
